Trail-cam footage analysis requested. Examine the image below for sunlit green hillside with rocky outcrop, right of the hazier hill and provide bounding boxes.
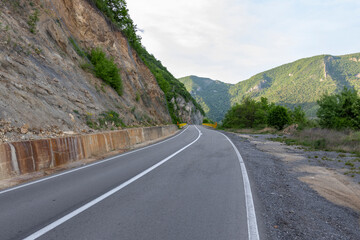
[230,53,360,116]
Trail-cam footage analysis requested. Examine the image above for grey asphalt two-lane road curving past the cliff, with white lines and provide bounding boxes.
[0,126,261,240]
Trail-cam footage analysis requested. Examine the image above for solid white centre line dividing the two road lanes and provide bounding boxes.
[24,126,201,240]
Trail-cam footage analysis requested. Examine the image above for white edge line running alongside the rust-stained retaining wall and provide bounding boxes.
[0,127,189,195]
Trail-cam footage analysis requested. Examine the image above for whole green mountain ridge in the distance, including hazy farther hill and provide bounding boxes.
[179,53,360,121]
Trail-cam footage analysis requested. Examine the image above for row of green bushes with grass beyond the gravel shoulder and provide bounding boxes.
[222,88,360,155]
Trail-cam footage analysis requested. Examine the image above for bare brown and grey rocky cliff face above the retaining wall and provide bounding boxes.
[0,0,177,142]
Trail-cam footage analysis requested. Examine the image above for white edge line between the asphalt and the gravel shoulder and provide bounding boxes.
[219,129,260,240]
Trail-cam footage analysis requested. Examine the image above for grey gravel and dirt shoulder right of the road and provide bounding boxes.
[225,133,360,239]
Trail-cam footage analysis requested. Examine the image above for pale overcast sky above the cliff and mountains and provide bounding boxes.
[127,0,360,83]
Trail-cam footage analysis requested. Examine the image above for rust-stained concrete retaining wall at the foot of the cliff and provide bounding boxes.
[0,125,178,179]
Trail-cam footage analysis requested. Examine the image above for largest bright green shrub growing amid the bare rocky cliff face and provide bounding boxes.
[90,48,123,95]
